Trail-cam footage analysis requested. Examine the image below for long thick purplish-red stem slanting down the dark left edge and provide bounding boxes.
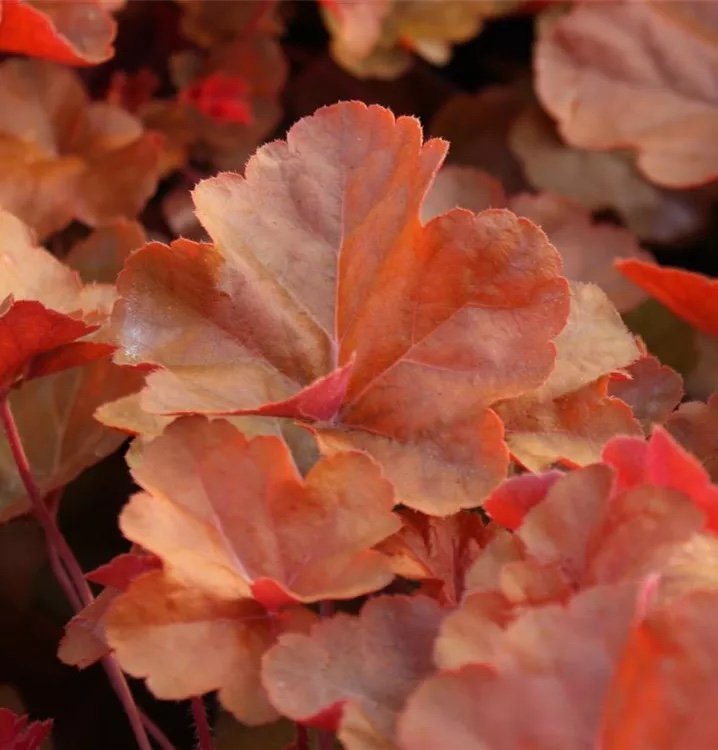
[0,391,157,750]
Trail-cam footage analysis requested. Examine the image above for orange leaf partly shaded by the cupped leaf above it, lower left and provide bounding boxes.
[106,571,314,724]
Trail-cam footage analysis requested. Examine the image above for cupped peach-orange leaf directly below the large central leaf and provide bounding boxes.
[120,417,400,608]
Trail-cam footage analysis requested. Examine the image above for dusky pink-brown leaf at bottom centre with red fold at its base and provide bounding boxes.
[262,596,443,750]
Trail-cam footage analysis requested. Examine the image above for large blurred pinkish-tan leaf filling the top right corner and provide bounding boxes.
[535,2,718,187]
